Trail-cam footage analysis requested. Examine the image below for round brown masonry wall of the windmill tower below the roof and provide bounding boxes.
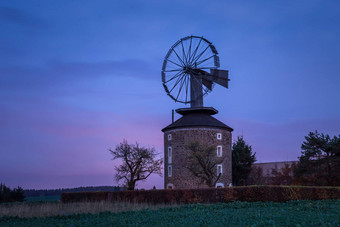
[164,127,232,188]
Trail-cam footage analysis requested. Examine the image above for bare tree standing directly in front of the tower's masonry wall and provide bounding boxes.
[186,142,224,188]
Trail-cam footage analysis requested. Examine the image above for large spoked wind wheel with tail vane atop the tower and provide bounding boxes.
[162,36,229,108]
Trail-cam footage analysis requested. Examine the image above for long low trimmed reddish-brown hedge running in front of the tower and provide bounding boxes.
[61,186,340,204]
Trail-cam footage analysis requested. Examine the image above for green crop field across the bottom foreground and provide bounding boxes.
[0,200,340,227]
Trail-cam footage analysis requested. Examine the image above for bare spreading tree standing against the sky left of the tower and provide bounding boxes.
[109,140,163,190]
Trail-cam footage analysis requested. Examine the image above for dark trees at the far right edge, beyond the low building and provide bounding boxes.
[294,131,340,186]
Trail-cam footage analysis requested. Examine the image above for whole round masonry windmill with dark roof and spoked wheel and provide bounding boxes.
[162,36,233,189]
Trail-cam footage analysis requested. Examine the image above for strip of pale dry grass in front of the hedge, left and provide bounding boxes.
[0,202,178,217]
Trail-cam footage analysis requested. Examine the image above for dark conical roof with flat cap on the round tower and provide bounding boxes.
[162,107,233,132]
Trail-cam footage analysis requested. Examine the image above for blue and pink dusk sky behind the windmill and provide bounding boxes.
[0,0,340,189]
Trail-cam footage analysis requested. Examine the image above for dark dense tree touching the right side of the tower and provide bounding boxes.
[232,136,256,185]
